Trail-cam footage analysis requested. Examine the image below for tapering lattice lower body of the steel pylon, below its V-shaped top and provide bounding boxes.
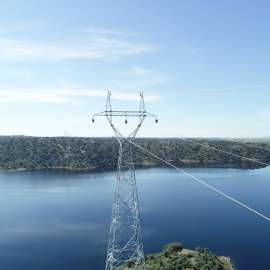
[106,137,146,270]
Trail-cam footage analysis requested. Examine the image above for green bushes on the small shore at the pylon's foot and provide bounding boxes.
[122,243,232,270]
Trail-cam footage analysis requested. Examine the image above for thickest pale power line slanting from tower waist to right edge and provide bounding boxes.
[119,133,270,221]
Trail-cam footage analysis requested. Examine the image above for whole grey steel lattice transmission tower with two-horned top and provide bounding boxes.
[92,92,158,270]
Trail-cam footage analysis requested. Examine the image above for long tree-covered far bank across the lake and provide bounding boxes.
[0,136,270,171]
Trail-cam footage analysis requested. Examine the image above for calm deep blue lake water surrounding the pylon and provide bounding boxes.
[0,168,270,270]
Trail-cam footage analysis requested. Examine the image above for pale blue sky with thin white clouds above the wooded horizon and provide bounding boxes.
[0,0,270,137]
